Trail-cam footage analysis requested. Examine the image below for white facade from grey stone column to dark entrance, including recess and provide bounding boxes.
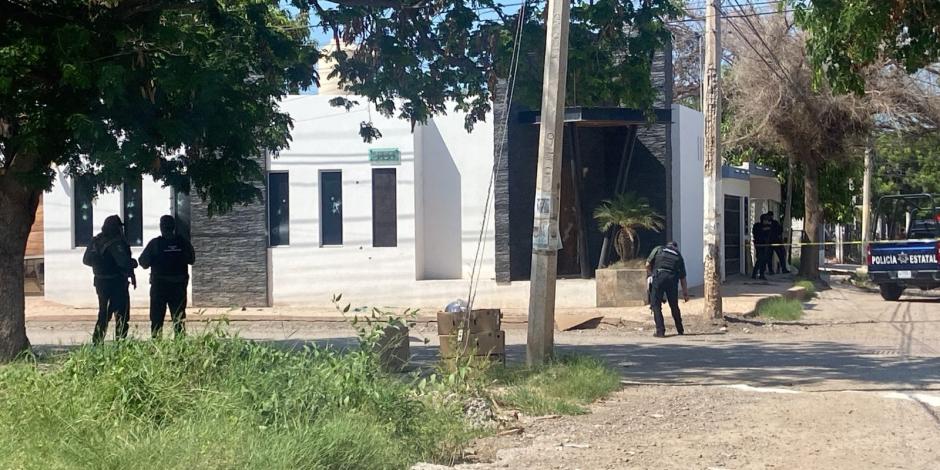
[270,96,520,307]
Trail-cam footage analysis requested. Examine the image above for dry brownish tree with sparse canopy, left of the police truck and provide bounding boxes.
[727,14,940,277]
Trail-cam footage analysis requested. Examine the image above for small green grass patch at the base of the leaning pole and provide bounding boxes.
[490,356,620,415]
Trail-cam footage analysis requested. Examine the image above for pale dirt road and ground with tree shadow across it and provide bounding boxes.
[20,280,940,470]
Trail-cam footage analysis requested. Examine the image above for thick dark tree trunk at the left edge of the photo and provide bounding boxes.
[0,175,41,362]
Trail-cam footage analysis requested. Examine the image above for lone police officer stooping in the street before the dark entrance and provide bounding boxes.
[646,242,689,338]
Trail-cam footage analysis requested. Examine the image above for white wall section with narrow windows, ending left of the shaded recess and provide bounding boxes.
[269,96,415,305]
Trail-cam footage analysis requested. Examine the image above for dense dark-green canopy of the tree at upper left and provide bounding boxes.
[0,0,318,210]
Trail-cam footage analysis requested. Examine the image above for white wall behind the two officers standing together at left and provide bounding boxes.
[43,172,176,308]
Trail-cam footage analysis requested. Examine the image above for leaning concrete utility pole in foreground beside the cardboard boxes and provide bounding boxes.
[526,0,570,365]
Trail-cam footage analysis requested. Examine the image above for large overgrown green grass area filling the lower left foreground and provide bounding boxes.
[0,328,476,469]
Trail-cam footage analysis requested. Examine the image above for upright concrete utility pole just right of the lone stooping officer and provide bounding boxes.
[702,0,723,319]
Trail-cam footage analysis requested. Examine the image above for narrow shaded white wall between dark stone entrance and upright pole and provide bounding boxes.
[672,105,705,286]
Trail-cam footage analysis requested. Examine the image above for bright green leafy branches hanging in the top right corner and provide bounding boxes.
[790,0,940,93]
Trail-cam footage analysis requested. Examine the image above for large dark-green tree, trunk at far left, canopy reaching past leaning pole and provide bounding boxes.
[0,0,672,361]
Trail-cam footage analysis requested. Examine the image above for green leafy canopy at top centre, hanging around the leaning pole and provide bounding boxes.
[324,0,682,129]
